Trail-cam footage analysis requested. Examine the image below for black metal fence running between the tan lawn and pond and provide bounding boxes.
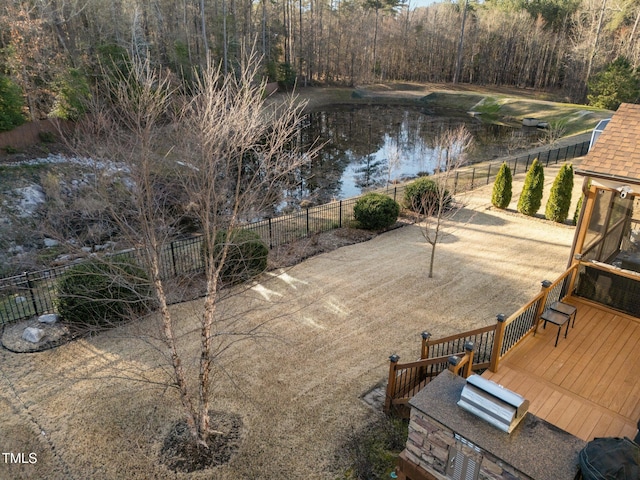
[0,142,589,325]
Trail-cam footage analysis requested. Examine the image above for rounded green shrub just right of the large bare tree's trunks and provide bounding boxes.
[209,229,269,283]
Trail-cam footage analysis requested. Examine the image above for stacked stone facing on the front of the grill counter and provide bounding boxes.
[404,408,531,480]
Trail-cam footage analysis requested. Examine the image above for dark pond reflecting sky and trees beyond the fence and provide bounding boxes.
[287,105,514,205]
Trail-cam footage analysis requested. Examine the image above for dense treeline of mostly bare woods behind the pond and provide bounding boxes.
[0,0,640,124]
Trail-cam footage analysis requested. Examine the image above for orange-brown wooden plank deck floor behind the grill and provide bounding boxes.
[483,298,640,441]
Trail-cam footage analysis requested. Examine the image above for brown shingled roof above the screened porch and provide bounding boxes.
[576,103,640,184]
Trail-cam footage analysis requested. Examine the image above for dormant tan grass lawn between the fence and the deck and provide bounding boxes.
[0,173,579,479]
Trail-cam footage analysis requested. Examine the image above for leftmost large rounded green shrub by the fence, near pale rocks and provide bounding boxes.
[57,257,152,329]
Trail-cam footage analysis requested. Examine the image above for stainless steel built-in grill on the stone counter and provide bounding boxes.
[458,375,529,433]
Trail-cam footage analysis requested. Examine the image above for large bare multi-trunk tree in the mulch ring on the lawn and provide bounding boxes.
[63,51,314,451]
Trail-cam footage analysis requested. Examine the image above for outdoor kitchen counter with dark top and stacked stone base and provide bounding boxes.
[397,370,586,480]
